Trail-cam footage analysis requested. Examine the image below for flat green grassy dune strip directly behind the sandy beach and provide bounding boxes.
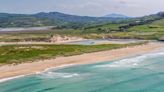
[0,43,143,64]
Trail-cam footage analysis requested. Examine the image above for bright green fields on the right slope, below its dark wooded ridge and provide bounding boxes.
[76,18,164,40]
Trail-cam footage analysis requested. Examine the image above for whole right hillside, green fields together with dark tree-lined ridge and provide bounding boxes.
[52,12,164,40]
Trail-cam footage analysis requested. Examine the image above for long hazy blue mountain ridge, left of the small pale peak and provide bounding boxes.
[33,12,125,23]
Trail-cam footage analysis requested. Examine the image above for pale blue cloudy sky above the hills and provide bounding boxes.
[0,0,164,16]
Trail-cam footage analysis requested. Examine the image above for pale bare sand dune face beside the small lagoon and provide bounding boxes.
[50,35,83,43]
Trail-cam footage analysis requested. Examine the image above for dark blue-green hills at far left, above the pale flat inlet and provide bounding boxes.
[0,13,60,28]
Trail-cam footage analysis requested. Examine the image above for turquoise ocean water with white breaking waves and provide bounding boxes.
[0,51,164,92]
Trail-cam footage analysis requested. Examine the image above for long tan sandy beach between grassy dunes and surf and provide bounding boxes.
[0,43,164,79]
